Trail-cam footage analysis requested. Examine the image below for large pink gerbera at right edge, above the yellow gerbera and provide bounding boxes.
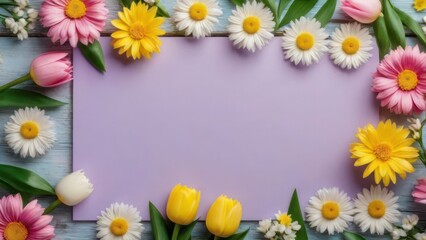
[372,46,426,114]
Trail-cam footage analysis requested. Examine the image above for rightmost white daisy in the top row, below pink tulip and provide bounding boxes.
[329,22,373,69]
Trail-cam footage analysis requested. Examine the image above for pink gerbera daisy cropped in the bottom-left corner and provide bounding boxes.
[0,194,55,240]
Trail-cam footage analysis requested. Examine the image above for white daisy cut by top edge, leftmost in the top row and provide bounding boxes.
[172,0,222,38]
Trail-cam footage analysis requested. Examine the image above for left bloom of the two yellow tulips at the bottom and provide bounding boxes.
[167,184,201,225]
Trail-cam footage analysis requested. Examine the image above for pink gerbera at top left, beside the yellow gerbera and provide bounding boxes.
[40,0,108,47]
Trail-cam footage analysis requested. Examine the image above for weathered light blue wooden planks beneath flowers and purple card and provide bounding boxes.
[0,0,426,240]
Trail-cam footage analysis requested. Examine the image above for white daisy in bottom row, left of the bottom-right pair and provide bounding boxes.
[306,188,353,235]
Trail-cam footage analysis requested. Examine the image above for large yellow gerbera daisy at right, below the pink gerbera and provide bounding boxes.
[350,120,419,186]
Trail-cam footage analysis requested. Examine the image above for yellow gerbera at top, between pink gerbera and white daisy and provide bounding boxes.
[111,2,166,59]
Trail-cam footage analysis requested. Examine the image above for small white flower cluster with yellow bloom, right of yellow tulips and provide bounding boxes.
[257,212,301,240]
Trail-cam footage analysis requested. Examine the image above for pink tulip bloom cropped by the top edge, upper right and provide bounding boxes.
[342,0,382,23]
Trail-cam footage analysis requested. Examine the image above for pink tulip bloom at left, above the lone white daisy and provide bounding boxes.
[30,52,72,87]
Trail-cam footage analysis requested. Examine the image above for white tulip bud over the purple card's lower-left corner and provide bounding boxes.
[55,170,93,206]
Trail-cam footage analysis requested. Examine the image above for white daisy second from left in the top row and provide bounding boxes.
[228,1,275,52]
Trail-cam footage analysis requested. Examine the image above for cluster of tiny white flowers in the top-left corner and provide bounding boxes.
[4,0,38,41]
